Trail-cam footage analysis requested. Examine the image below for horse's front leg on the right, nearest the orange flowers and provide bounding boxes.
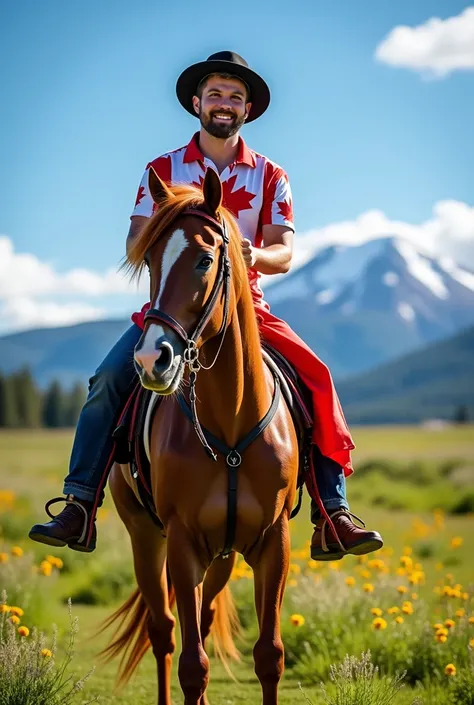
[248,514,290,705]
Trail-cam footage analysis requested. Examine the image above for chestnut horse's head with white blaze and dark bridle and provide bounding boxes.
[129,169,235,395]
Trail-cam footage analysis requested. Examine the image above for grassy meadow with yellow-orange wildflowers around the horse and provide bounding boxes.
[0,427,474,705]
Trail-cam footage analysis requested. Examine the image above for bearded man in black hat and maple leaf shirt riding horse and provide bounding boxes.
[30,51,382,560]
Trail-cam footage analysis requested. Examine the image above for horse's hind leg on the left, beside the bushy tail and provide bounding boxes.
[110,466,176,705]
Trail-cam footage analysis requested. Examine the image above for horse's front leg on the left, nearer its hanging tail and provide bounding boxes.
[167,516,209,705]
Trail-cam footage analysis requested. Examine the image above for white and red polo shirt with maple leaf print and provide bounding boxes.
[132,133,294,328]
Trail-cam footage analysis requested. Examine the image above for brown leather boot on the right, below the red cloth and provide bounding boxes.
[311,509,383,561]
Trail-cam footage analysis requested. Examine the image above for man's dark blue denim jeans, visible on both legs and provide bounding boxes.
[63,324,348,519]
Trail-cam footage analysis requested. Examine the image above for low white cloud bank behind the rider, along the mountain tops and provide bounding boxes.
[0,200,474,333]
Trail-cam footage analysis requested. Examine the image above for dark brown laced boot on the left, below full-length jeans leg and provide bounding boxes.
[28,495,97,553]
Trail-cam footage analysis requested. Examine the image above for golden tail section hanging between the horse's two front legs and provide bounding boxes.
[211,585,241,681]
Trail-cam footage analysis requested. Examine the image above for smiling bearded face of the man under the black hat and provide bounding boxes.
[193,76,251,139]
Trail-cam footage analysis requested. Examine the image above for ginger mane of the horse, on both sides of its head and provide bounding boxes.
[123,184,249,291]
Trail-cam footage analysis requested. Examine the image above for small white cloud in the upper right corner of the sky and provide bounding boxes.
[375,7,474,78]
